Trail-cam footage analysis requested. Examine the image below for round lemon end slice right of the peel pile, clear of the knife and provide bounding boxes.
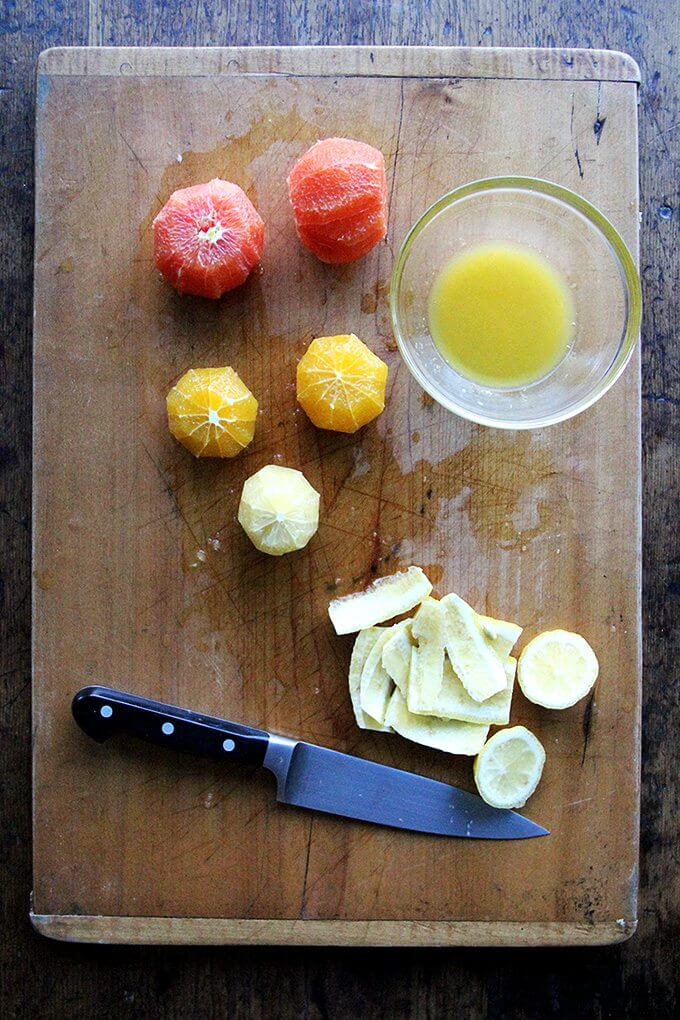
[517,630,599,708]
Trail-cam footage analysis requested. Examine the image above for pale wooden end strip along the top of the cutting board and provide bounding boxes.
[38,46,641,85]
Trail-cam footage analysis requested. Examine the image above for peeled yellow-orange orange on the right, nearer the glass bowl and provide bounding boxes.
[298,334,387,432]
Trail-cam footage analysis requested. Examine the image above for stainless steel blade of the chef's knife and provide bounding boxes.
[264,735,548,839]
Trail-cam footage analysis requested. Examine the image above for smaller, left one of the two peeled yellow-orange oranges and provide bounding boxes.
[167,368,257,457]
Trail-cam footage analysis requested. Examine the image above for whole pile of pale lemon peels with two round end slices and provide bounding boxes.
[328,566,597,808]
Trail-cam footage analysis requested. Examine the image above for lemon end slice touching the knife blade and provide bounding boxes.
[474,726,545,808]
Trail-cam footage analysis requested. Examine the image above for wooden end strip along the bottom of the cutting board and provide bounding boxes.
[30,911,637,948]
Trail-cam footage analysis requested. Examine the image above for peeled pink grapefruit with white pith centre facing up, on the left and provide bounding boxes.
[153,179,264,298]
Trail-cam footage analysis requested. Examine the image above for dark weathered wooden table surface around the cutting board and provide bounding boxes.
[0,0,680,1020]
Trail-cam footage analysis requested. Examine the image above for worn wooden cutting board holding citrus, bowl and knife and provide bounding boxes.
[32,48,640,945]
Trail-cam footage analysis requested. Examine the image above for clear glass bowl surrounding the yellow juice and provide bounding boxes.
[389,177,641,428]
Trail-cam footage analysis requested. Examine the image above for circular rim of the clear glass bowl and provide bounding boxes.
[389,175,642,429]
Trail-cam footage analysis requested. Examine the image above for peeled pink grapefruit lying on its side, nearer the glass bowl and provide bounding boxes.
[287,138,387,265]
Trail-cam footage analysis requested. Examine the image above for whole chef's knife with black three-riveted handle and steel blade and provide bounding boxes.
[72,686,548,839]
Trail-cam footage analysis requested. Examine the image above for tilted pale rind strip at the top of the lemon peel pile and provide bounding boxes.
[328,567,432,634]
